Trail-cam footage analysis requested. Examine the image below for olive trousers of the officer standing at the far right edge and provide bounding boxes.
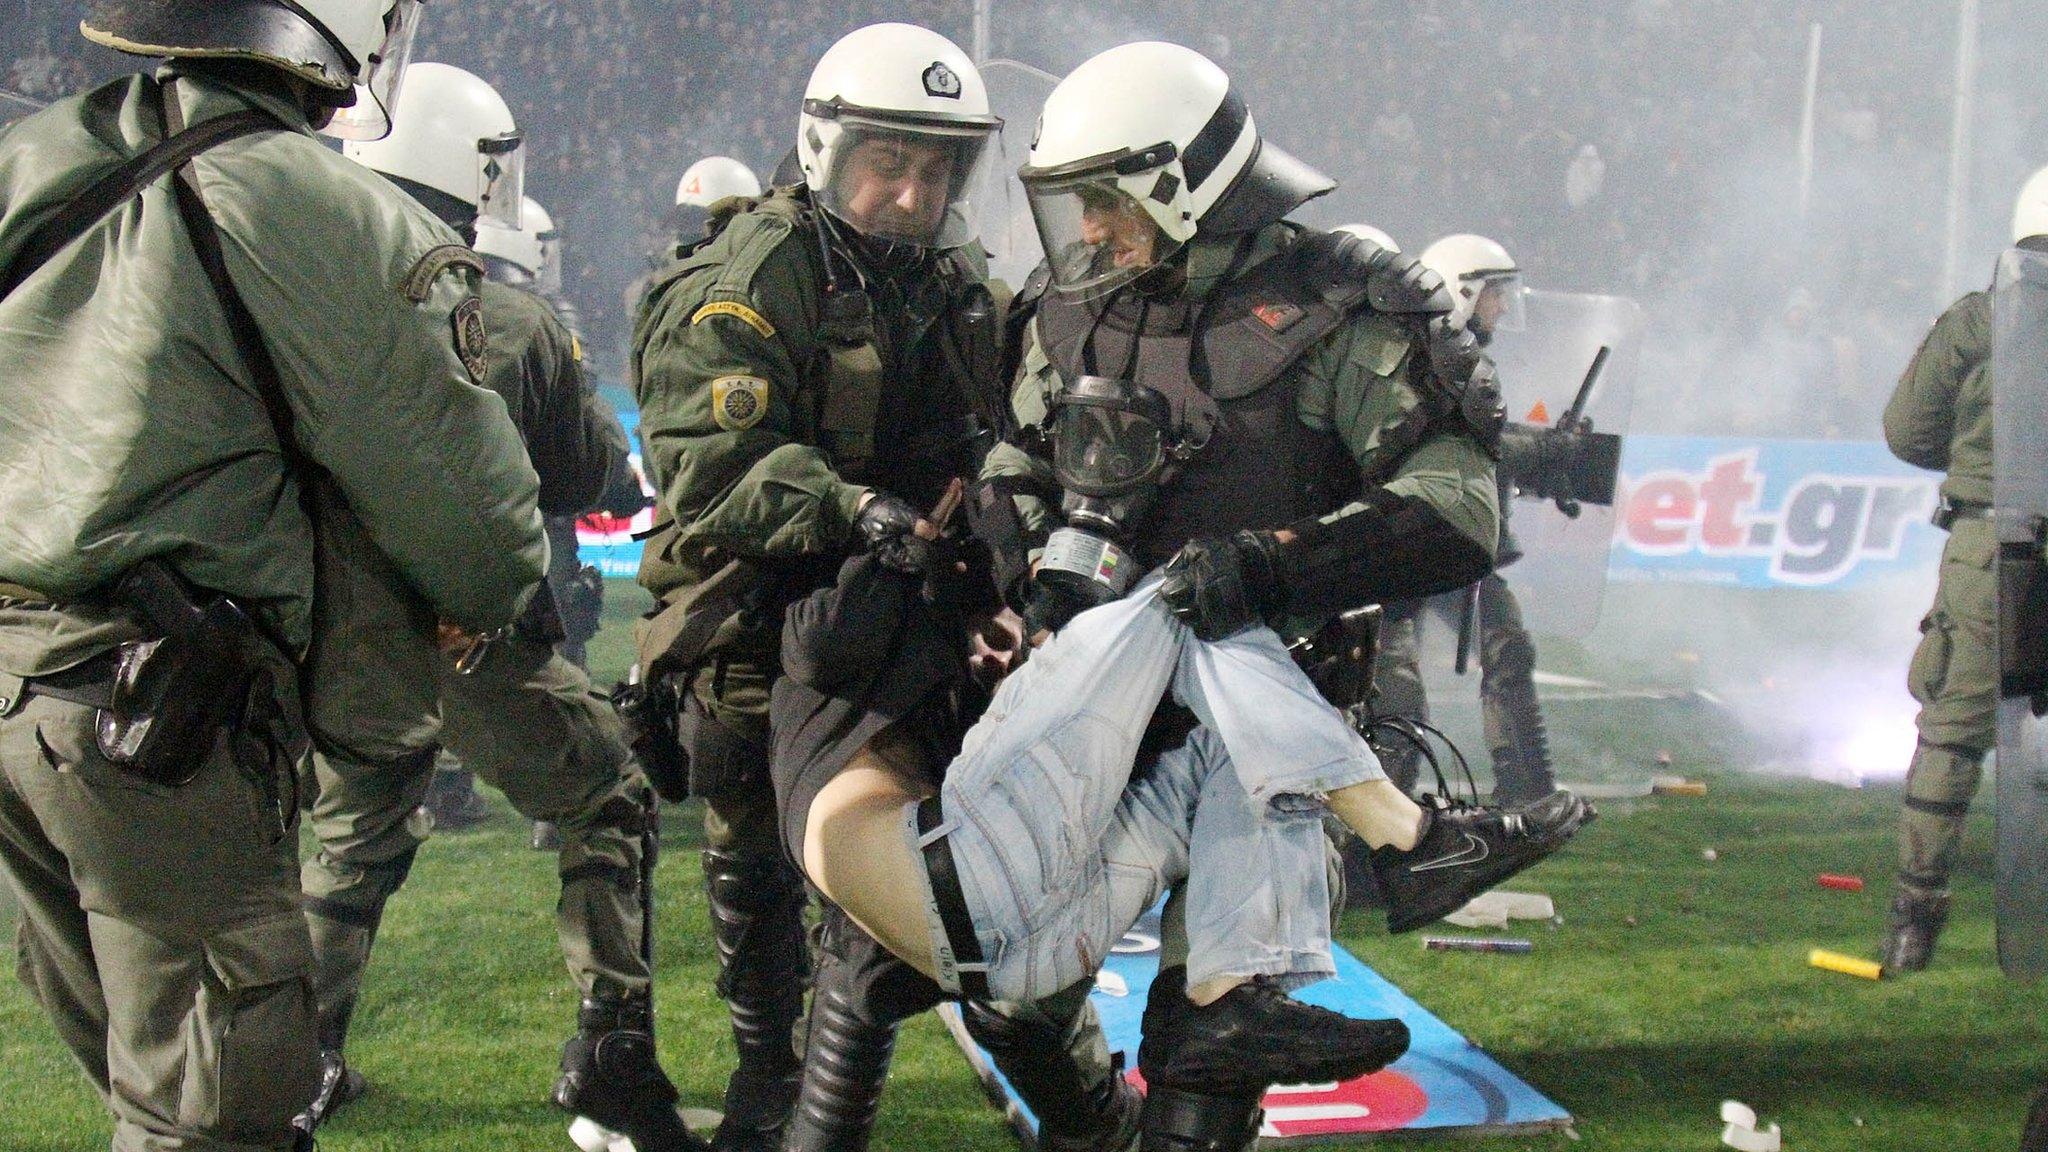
[1898,519,1999,892]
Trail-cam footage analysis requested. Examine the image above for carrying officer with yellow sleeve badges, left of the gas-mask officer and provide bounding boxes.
[633,25,1135,1150]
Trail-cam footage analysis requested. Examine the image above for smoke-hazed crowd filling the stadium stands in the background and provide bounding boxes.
[0,0,2048,439]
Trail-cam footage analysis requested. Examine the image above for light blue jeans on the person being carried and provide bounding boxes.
[903,576,1384,1000]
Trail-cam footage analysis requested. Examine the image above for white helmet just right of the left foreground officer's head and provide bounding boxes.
[342,61,526,228]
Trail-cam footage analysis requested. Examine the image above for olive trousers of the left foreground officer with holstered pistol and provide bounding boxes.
[0,693,319,1152]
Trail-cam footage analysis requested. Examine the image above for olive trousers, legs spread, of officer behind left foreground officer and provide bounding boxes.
[301,510,649,1047]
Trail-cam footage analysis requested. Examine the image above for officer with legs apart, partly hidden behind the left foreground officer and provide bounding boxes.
[303,64,700,1150]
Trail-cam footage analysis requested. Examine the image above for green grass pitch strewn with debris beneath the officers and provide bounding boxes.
[0,582,2048,1152]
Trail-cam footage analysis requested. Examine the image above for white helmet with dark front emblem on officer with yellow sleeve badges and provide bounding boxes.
[797,25,1004,248]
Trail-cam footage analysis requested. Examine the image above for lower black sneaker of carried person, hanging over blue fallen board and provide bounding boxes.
[1147,978,1409,1097]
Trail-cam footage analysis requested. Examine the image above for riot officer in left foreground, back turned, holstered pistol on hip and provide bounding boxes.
[0,0,545,1150]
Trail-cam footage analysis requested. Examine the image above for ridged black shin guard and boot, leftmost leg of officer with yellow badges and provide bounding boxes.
[705,849,811,1152]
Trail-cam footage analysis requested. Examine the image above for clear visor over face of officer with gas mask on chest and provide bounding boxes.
[1024,170,1182,297]
